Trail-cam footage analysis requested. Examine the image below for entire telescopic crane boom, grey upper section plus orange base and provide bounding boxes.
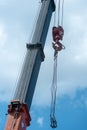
[5,0,55,130]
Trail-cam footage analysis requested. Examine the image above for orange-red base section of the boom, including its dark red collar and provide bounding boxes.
[5,100,31,130]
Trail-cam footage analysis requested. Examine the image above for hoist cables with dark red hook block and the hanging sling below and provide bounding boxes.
[50,0,65,128]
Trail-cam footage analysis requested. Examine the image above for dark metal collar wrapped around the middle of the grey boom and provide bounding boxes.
[26,43,45,62]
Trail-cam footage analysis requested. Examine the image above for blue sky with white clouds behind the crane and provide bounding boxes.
[0,0,87,130]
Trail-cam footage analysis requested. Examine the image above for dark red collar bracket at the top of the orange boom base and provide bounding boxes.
[6,100,31,126]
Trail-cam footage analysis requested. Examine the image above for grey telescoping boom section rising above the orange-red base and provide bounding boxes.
[14,0,55,109]
